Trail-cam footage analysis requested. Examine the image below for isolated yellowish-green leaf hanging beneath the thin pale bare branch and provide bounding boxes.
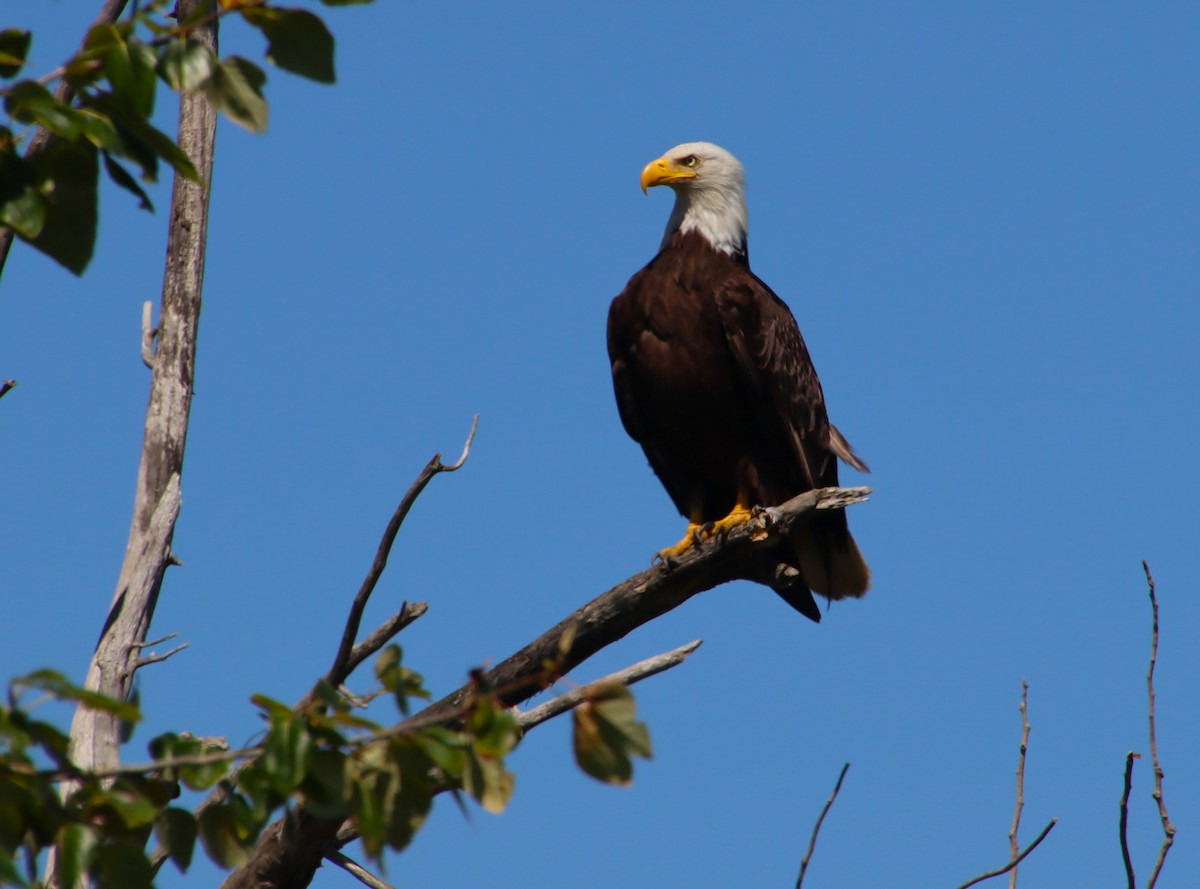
[572,684,653,786]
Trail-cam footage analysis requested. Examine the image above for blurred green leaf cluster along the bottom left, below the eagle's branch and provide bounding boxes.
[0,644,650,889]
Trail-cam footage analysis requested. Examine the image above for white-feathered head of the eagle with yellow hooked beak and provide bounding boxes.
[642,142,749,256]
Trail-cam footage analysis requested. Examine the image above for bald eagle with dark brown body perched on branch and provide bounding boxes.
[608,142,870,620]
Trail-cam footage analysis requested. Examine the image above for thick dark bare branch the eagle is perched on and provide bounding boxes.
[223,484,870,889]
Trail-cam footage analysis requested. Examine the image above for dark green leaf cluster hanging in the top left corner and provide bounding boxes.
[0,0,355,275]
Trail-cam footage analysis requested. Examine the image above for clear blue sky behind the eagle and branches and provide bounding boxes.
[0,0,1200,889]
